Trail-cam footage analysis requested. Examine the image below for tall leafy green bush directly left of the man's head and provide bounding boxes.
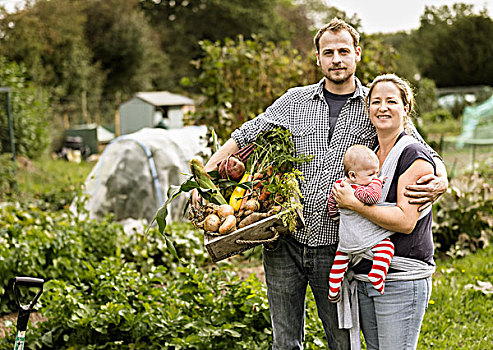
[184,35,315,140]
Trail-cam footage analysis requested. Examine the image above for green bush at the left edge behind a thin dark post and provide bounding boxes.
[0,56,49,158]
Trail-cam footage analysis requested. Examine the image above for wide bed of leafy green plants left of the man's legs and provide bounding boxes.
[0,198,326,350]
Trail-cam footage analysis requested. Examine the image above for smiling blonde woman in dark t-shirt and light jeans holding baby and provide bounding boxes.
[333,74,436,350]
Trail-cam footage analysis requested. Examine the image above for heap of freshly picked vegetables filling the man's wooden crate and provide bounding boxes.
[151,127,312,254]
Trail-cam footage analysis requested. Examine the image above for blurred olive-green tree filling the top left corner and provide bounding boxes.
[0,0,102,121]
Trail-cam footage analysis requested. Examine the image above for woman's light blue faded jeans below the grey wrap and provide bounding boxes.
[358,277,431,350]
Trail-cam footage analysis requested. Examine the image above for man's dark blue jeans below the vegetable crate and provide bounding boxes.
[263,236,350,350]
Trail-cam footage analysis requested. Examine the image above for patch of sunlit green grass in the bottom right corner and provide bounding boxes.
[418,246,493,350]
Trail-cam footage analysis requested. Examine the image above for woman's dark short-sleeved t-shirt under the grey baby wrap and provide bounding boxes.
[353,135,436,274]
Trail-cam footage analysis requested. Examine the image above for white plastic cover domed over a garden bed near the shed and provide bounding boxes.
[78,126,209,222]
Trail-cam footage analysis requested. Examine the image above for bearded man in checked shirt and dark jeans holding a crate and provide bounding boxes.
[195,19,447,349]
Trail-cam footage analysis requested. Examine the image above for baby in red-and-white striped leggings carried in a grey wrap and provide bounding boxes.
[328,145,394,303]
